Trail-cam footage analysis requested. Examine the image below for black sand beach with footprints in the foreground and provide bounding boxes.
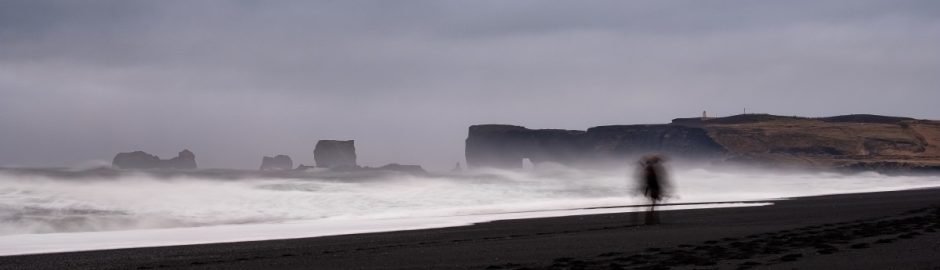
[0,189,940,269]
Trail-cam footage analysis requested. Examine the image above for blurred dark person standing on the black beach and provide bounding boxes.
[637,155,672,225]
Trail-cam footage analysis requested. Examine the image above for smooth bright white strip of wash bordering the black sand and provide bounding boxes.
[0,200,773,258]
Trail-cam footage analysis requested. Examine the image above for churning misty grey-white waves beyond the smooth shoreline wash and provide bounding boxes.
[0,167,940,235]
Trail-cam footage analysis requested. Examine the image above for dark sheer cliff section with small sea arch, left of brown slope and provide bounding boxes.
[466,125,724,168]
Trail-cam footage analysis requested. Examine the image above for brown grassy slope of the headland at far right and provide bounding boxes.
[688,115,940,171]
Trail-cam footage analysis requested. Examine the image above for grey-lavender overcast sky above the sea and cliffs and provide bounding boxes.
[0,0,940,169]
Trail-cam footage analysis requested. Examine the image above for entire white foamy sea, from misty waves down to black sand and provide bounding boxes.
[0,167,940,255]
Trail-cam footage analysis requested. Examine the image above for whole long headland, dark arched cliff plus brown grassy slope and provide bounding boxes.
[466,114,940,171]
